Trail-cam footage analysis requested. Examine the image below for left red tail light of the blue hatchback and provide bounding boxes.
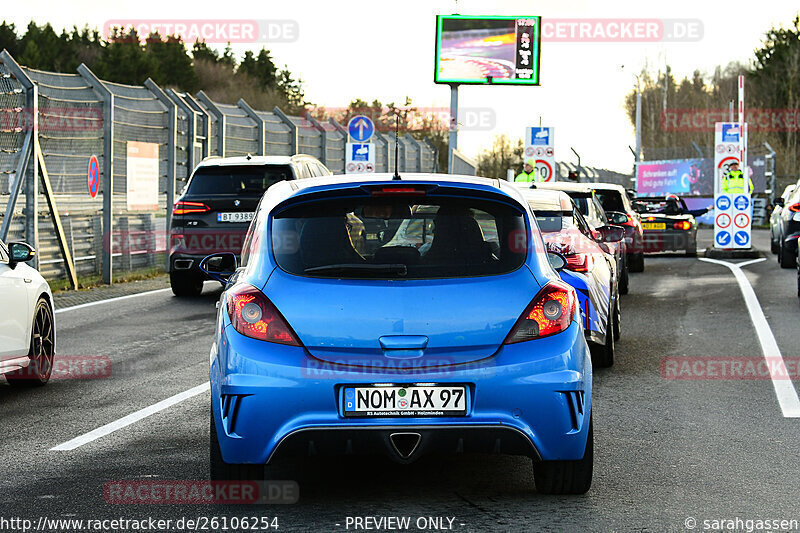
[227,283,300,346]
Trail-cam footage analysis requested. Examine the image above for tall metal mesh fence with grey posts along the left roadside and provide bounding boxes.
[0,51,438,282]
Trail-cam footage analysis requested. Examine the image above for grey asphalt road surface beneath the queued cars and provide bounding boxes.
[0,232,800,531]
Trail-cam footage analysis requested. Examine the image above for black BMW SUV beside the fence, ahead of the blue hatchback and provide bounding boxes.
[169,154,331,296]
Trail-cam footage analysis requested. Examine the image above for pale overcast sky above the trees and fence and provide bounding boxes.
[10,0,800,171]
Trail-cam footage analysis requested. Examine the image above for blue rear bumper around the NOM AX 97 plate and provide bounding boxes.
[210,313,592,464]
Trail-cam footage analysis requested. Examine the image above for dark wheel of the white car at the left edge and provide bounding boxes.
[6,298,56,387]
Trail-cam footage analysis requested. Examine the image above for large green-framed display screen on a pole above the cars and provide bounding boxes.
[433,15,542,85]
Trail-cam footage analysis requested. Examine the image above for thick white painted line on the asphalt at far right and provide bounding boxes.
[700,257,800,418]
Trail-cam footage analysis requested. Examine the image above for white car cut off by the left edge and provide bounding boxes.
[0,241,56,387]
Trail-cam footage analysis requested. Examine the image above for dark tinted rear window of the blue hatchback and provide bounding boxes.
[271,197,527,279]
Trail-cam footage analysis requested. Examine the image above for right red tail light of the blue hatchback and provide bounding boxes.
[503,281,577,344]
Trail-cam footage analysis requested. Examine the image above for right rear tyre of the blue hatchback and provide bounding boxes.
[533,417,594,494]
